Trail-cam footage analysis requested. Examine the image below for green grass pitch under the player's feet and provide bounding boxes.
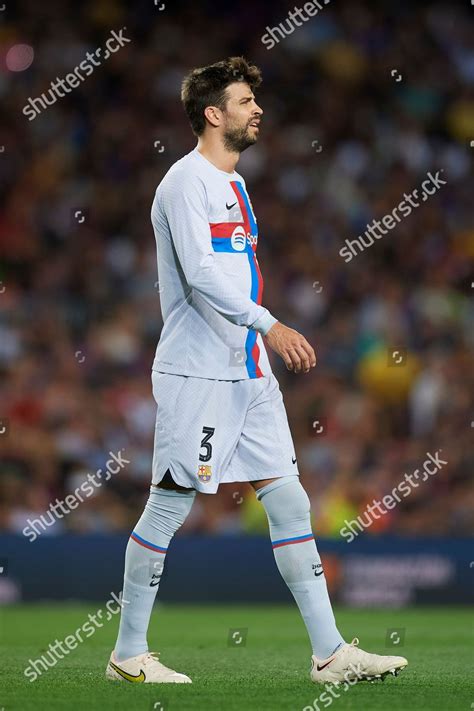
[0,604,474,711]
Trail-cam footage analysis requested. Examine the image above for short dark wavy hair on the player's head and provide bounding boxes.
[181,57,262,136]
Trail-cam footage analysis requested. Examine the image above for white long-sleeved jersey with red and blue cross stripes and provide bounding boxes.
[151,148,276,380]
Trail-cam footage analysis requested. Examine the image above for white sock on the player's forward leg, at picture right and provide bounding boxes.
[256,475,344,659]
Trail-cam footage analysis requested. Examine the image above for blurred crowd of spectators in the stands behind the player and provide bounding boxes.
[0,0,474,536]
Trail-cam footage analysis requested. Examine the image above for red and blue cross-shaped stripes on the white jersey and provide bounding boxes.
[209,180,263,378]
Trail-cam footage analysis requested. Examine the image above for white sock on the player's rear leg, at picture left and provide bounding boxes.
[115,487,196,661]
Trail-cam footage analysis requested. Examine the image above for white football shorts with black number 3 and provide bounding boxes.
[152,370,299,494]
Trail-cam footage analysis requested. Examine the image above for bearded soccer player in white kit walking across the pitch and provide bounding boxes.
[106,57,407,683]
